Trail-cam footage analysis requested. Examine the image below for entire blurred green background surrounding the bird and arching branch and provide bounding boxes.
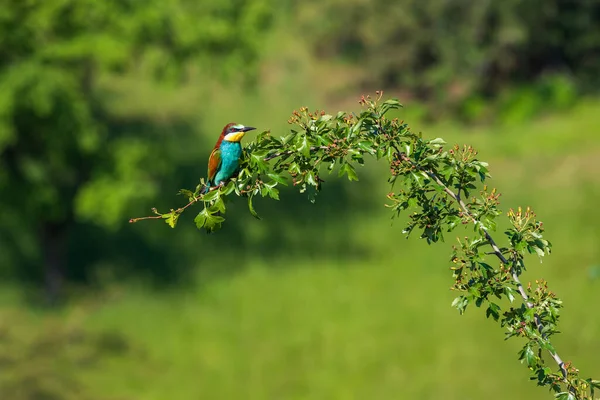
[0,0,600,400]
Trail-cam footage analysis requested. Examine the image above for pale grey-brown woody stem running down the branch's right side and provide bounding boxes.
[396,149,568,382]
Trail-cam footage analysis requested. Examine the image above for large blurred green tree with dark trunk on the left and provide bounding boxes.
[0,0,271,300]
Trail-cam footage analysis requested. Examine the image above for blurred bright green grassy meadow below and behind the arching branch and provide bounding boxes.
[0,98,600,400]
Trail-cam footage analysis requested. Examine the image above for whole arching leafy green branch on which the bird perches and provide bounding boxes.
[130,92,596,399]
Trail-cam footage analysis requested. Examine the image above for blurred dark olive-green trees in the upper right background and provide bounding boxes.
[294,0,600,114]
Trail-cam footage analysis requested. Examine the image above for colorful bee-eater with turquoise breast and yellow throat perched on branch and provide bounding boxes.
[202,122,256,194]
